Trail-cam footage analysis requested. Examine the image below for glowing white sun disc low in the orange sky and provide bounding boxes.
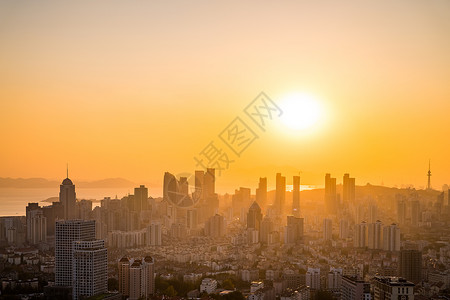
[280,94,322,131]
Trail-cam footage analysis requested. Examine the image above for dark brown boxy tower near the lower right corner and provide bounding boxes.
[398,250,422,284]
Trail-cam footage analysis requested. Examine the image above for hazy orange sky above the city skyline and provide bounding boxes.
[0,0,450,191]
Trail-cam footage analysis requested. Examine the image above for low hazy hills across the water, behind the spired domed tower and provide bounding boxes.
[0,177,137,188]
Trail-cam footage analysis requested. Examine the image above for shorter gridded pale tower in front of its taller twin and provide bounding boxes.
[72,240,108,300]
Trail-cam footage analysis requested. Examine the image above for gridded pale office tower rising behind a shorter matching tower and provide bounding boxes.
[55,220,95,286]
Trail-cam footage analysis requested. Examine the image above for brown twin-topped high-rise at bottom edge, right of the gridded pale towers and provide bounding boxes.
[128,256,155,300]
